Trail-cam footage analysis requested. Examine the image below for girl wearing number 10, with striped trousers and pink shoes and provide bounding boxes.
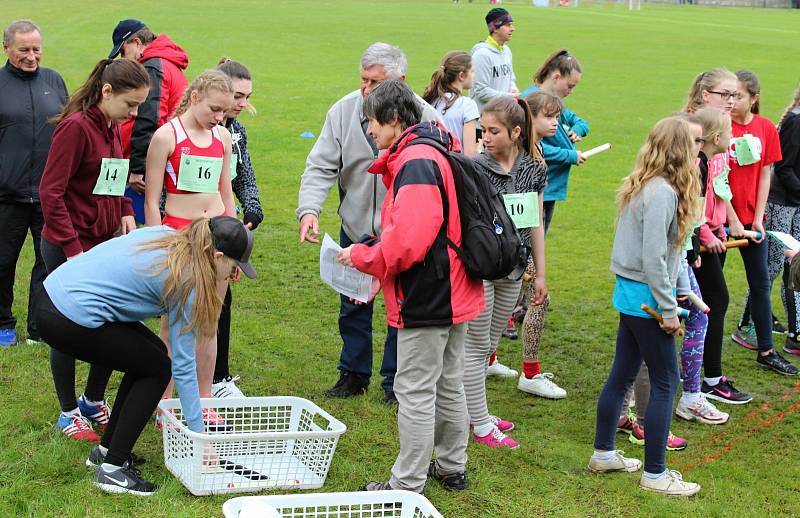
[464,96,560,449]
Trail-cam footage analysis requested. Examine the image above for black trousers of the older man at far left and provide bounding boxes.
[0,202,47,340]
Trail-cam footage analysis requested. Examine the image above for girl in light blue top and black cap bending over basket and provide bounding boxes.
[36,216,255,495]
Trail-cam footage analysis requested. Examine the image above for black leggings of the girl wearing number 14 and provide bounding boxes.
[41,239,111,412]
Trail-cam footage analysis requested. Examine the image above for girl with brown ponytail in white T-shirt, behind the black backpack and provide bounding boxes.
[422,51,480,156]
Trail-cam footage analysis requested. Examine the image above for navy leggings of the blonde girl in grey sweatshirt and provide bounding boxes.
[594,313,680,473]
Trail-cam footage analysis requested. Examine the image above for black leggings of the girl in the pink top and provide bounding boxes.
[694,252,729,378]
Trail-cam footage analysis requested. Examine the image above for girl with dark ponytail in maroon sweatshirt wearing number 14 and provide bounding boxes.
[39,59,150,442]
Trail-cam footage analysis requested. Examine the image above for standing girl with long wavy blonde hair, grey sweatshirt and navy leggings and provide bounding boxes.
[589,117,700,496]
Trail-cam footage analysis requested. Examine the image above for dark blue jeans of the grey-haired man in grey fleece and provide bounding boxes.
[338,230,397,391]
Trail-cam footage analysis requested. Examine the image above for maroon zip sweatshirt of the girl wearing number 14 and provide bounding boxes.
[39,106,133,257]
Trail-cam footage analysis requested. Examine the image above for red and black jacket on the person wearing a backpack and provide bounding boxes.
[351,122,484,328]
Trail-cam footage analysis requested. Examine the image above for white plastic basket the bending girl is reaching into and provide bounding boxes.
[158,397,347,495]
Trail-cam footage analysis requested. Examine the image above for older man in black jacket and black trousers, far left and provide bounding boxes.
[0,20,67,346]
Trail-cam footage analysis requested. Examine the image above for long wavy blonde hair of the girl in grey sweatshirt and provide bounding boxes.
[617,116,700,247]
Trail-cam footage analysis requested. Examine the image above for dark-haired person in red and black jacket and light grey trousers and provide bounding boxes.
[339,80,484,493]
